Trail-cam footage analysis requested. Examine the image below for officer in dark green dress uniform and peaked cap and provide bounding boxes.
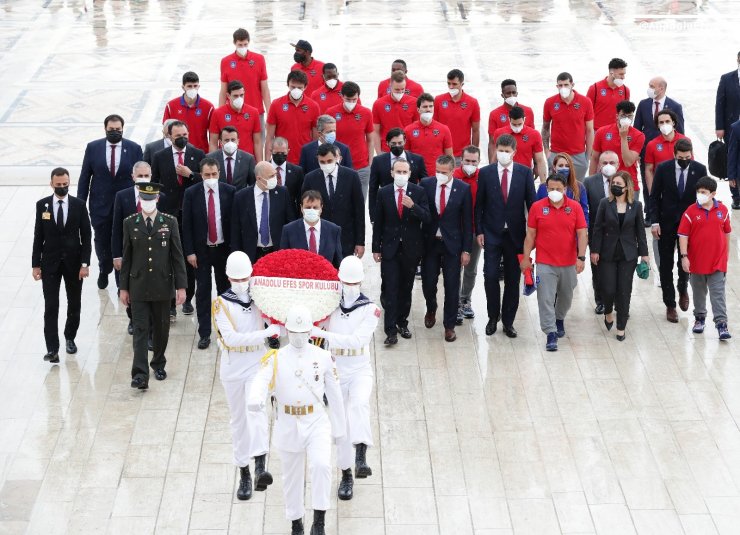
[119,182,188,390]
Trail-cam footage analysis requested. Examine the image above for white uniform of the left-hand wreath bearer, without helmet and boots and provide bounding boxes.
[212,290,269,467]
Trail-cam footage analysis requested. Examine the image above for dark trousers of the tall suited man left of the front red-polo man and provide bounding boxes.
[483,230,523,327]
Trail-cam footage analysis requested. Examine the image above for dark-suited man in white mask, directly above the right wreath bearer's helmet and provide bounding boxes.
[303,143,365,258]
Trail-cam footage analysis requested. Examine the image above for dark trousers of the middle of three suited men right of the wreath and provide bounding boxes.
[421,239,460,329]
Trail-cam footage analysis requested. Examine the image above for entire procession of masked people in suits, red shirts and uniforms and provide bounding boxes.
[32,29,740,533]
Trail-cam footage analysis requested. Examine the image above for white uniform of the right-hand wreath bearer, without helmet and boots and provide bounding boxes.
[322,296,380,470]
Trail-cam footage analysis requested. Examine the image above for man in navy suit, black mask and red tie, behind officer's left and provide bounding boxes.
[77,115,142,290]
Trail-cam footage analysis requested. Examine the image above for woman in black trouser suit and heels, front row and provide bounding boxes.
[591,171,650,342]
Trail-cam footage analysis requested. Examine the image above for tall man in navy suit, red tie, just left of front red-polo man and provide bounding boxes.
[475,134,537,338]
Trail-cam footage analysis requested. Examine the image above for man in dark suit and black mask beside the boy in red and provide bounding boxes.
[650,138,707,323]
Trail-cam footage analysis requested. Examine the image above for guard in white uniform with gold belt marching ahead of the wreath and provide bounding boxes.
[248,305,345,535]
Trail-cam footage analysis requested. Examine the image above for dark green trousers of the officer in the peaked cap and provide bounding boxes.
[131,300,170,380]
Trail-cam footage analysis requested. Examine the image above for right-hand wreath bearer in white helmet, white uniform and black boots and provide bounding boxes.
[311,256,380,500]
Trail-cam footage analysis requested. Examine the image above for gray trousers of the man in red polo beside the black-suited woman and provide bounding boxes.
[537,264,578,334]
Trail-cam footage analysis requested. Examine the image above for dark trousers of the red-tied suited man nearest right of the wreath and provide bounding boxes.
[380,242,420,335]
